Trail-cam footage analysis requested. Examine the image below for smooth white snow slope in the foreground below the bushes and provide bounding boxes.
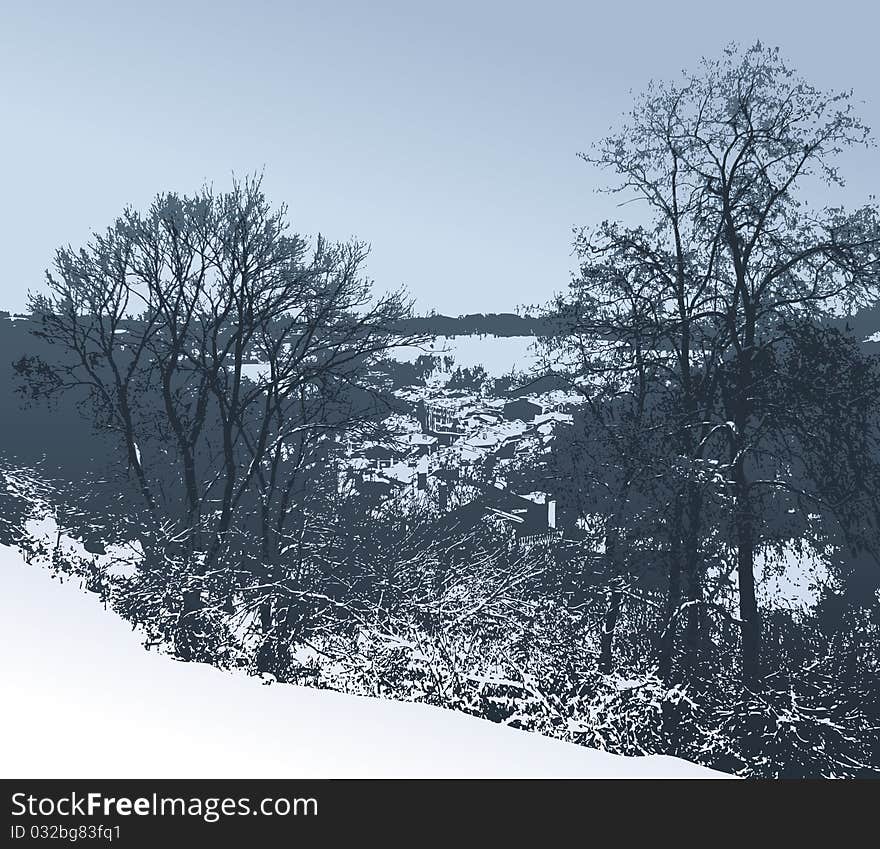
[0,546,722,778]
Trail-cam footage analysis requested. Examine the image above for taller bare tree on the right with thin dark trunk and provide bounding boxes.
[556,44,880,683]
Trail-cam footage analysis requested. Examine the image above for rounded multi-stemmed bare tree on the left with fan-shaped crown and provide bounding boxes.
[19,178,413,660]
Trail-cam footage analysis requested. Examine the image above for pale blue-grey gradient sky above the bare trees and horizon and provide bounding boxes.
[0,0,880,315]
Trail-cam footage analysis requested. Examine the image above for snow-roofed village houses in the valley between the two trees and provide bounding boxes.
[338,360,583,546]
